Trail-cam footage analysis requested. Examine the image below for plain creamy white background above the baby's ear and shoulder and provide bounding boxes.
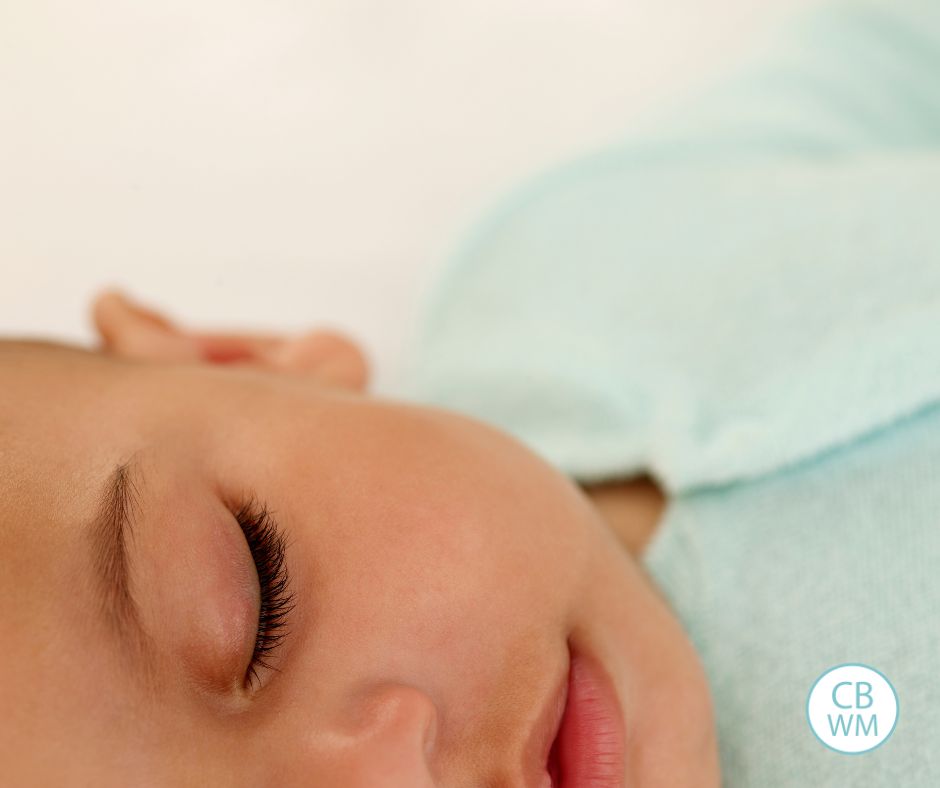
[0,0,813,393]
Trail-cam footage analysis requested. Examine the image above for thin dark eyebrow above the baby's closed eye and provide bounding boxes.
[89,454,147,660]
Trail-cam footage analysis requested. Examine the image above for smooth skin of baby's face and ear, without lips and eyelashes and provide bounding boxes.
[0,292,719,788]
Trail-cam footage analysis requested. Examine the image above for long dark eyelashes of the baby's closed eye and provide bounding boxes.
[235,498,294,686]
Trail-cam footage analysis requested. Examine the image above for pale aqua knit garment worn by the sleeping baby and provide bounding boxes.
[403,1,940,788]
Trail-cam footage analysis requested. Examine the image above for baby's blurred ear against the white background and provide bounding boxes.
[92,289,369,391]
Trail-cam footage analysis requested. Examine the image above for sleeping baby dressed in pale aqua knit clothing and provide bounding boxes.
[0,0,940,788]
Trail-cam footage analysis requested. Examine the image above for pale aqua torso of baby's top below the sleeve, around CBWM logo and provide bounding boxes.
[646,407,940,788]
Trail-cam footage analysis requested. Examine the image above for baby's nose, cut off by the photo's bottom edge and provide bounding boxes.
[326,684,438,788]
